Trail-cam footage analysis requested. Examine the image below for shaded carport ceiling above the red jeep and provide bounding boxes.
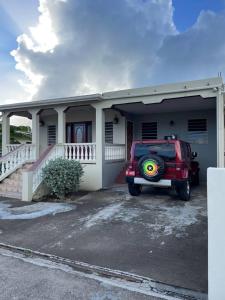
[114,96,216,115]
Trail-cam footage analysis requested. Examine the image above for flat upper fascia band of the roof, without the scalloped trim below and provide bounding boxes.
[0,77,223,112]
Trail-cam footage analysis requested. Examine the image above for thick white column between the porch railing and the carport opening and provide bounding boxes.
[96,107,105,188]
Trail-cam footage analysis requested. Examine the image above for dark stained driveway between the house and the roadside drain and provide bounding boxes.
[0,187,207,292]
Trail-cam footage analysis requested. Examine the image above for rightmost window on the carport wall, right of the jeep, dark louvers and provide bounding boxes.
[187,119,208,144]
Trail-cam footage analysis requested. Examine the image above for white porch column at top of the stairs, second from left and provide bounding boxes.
[30,109,40,159]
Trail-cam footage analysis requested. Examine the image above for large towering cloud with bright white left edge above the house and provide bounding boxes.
[10,0,176,98]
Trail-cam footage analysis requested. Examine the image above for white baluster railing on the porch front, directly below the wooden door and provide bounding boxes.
[61,143,96,162]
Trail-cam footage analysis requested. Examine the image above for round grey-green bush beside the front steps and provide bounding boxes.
[42,158,84,199]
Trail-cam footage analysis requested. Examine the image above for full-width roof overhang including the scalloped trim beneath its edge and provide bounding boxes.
[0,77,221,112]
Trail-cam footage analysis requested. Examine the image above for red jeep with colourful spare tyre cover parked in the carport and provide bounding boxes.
[126,137,200,201]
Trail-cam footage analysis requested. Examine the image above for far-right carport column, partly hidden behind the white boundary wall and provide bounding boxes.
[216,90,224,168]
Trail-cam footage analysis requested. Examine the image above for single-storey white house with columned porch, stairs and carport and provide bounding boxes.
[0,77,224,200]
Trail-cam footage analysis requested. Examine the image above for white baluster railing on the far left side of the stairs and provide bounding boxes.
[0,144,35,181]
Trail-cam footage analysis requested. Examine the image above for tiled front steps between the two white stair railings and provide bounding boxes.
[0,163,32,199]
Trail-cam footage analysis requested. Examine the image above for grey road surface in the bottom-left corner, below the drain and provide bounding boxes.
[0,250,160,300]
